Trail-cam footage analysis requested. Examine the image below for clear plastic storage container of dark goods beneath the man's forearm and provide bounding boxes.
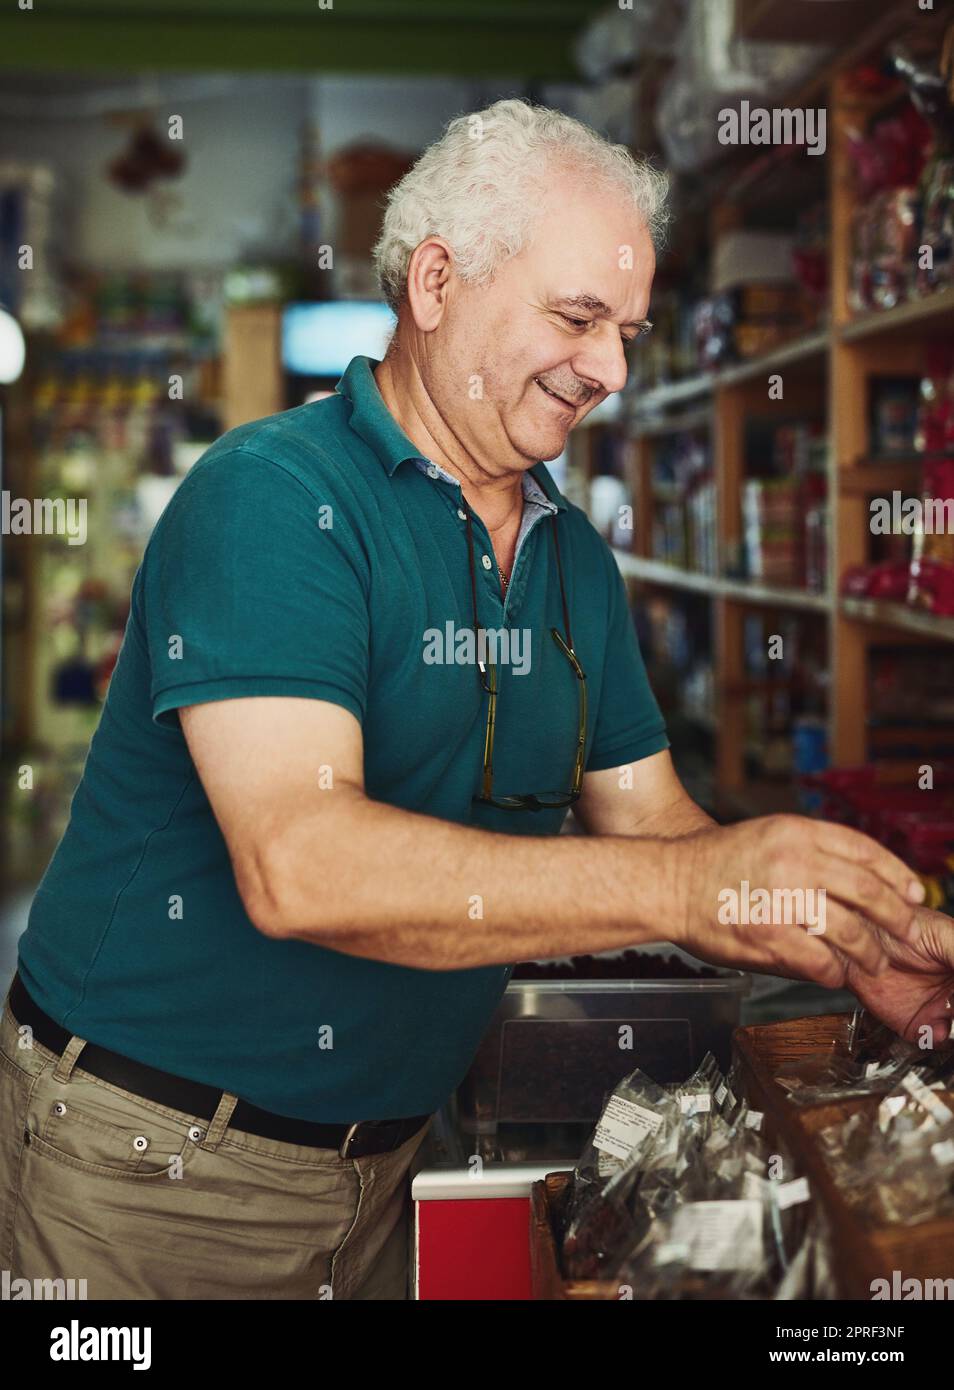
[458,945,751,1134]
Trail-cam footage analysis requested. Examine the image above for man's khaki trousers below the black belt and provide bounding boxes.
[0,1001,427,1300]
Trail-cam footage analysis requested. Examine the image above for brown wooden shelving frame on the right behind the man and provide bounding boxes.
[616,19,954,815]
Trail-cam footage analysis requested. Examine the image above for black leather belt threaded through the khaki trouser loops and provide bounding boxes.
[8,973,430,1158]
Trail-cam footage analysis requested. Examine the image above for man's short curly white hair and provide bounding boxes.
[374,100,669,311]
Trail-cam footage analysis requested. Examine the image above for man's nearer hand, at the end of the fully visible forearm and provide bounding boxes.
[672,816,923,990]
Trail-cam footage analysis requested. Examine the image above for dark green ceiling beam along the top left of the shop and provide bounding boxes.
[0,9,595,85]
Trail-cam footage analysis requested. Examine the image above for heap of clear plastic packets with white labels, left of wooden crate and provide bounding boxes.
[563,1056,827,1300]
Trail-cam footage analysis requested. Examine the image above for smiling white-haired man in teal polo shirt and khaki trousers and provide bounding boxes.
[0,101,954,1298]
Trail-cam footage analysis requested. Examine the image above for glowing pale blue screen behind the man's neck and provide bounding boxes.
[281,299,396,377]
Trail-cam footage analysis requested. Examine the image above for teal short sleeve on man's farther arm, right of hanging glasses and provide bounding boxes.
[587,546,669,773]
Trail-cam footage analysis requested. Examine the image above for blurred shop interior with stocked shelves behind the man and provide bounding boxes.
[0,0,954,1016]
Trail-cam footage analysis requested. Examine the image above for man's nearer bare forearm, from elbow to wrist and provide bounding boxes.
[266,790,695,970]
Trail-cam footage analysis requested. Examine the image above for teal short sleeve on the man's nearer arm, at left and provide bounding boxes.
[142,449,370,727]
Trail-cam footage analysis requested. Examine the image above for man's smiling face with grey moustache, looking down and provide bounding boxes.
[424,172,655,473]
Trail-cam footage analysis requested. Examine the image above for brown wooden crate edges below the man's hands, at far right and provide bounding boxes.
[733,1013,954,1300]
